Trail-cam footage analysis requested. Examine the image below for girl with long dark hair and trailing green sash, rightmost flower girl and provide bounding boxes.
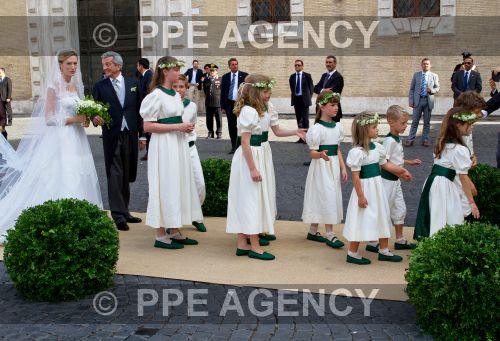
[414,107,479,239]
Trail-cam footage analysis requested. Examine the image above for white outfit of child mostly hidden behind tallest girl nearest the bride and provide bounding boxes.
[182,98,206,205]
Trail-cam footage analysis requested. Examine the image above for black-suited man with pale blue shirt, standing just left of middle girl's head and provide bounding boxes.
[220,58,248,154]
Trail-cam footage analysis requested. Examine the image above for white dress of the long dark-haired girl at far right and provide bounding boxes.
[424,143,472,236]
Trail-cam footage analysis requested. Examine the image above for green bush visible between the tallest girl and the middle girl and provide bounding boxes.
[201,159,231,217]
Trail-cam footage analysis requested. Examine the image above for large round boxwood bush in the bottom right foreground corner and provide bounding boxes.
[405,222,500,340]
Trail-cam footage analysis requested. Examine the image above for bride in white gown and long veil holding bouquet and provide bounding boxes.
[0,50,102,244]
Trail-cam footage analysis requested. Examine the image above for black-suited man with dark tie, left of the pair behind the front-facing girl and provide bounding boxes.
[288,59,314,135]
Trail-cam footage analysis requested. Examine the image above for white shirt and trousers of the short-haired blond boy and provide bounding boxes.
[382,134,406,225]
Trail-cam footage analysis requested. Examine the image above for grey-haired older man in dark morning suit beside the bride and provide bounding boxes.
[92,52,146,231]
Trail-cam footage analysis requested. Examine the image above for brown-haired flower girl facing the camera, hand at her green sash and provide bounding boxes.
[302,91,347,249]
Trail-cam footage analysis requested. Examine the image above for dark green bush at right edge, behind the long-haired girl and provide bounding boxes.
[469,164,500,226]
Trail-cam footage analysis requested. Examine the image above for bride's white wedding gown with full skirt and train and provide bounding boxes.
[0,91,102,240]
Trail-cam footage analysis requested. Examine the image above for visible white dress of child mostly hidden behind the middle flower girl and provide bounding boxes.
[260,102,279,221]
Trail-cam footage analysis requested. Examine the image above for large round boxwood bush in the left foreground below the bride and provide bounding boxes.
[4,199,119,301]
